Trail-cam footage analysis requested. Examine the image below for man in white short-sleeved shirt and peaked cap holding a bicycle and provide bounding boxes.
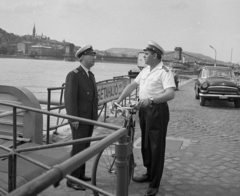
[116,41,175,196]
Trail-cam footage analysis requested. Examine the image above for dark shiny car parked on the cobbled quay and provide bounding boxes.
[194,66,240,108]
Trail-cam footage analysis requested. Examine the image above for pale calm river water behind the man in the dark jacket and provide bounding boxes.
[0,58,138,100]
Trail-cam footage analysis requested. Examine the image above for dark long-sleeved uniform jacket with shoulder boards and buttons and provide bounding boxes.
[64,66,98,122]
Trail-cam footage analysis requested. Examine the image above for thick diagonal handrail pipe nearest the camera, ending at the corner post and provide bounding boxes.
[5,128,127,196]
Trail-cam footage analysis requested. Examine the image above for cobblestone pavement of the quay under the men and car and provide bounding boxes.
[38,80,240,196]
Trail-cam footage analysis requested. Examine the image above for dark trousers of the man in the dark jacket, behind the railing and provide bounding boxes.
[71,123,94,179]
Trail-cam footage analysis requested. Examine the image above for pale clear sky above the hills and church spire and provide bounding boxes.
[0,0,240,64]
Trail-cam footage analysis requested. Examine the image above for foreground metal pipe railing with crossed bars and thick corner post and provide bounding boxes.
[0,102,129,196]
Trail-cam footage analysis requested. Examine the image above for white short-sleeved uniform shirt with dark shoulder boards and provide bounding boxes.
[134,62,176,99]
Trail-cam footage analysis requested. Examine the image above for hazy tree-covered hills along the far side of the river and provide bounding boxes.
[0,28,239,67]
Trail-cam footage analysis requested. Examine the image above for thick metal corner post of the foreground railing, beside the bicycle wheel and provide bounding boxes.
[115,132,129,196]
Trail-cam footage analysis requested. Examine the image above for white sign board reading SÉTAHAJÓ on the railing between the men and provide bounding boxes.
[97,78,130,105]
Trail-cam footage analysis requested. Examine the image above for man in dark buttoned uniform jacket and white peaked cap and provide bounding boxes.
[64,45,98,190]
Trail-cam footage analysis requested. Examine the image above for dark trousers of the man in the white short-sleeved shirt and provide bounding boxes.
[139,103,169,188]
